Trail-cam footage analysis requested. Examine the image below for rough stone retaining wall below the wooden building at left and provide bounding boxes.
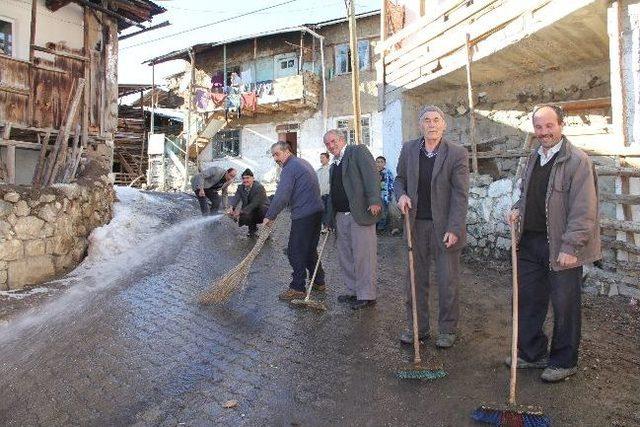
[0,175,114,290]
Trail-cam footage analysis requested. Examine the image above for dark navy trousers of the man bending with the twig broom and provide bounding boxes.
[287,212,324,292]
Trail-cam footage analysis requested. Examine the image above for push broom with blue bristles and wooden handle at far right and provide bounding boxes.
[471,221,551,427]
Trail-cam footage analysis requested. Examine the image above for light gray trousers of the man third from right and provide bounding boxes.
[336,212,378,300]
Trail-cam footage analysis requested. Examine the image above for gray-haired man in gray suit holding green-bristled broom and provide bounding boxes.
[394,105,469,348]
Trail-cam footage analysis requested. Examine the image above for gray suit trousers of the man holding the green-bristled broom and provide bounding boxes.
[407,219,460,335]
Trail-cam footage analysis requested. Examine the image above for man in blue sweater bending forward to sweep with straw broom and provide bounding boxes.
[264,141,325,301]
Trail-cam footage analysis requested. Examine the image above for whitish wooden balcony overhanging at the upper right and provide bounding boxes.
[376,0,609,103]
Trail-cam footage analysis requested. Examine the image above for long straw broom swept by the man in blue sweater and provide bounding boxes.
[200,225,274,304]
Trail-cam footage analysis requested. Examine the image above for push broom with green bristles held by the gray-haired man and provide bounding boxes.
[396,212,447,380]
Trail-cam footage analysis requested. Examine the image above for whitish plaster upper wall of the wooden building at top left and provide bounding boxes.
[0,0,84,60]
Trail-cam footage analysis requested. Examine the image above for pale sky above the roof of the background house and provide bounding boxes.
[118,0,381,84]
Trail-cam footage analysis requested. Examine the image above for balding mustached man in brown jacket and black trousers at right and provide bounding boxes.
[507,105,602,382]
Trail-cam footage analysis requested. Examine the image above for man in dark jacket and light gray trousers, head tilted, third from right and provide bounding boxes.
[324,129,382,310]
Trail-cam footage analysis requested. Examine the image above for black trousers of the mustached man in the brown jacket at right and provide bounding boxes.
[518,232,582,368]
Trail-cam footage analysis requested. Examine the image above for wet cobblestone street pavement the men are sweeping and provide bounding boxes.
[0,195,640,426]
